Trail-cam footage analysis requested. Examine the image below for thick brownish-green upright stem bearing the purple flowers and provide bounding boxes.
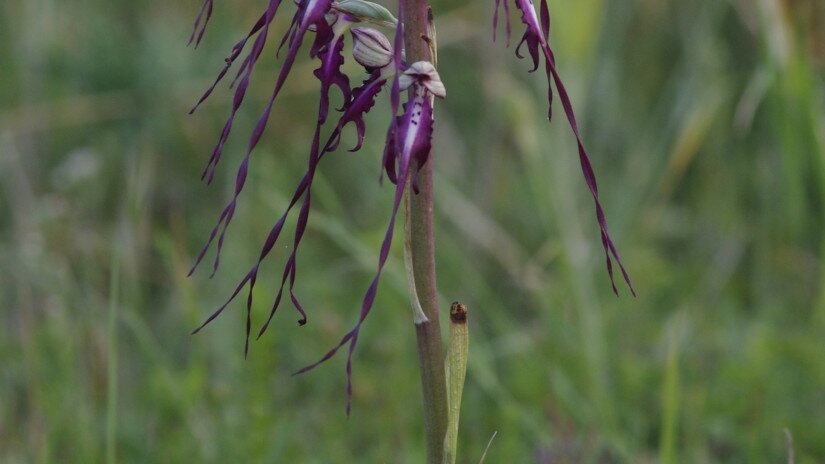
[402,0,447,464]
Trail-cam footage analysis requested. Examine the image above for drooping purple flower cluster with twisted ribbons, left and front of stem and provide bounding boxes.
[190,0,446,411]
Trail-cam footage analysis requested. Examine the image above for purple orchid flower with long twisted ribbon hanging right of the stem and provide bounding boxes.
[493,0,636,296]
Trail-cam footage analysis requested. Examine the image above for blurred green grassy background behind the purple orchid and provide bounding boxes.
[0,0,825,463]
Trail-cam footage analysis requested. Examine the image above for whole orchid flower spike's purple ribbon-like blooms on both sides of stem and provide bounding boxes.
[190,0,635,413]
